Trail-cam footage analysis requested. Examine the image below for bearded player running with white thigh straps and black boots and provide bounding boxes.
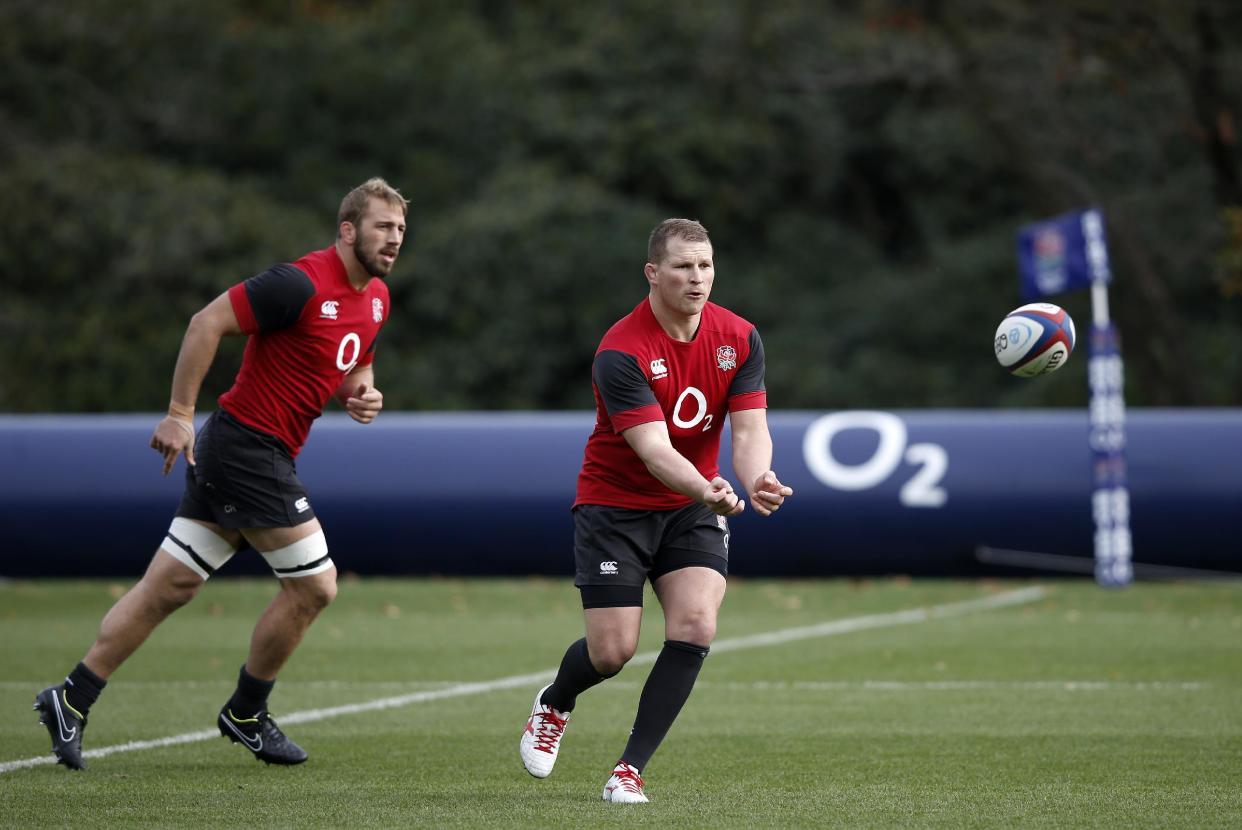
[35,178,407,769]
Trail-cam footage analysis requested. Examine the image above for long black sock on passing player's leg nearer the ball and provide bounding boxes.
[621,640,708,772]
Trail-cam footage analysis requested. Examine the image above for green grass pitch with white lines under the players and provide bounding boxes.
[0,579,1242,828]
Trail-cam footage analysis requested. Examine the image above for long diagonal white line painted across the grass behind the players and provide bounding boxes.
[0,588,1045,774]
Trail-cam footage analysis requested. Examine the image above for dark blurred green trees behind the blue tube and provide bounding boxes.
[0,0,1242,411]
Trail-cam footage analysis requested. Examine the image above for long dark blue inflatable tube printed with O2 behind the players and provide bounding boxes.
[0,410,1242,581]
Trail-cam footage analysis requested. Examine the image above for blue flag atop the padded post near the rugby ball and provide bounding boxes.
[1017,208,1112,302]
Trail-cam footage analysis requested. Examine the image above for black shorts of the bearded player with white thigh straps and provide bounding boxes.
[176,409,314,528]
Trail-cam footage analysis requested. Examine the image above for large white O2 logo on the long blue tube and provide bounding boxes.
[802,410,949,507]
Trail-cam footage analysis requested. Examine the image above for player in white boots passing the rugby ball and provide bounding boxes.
[519,219,794,803]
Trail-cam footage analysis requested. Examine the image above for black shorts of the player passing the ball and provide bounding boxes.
[574,504,729,608]
